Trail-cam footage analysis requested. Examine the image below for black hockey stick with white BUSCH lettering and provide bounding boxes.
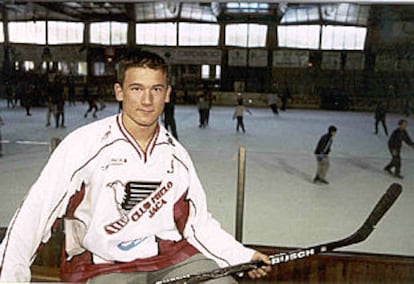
[156,183,402,284]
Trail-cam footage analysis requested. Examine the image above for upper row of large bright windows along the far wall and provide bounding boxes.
[0,21,367,50]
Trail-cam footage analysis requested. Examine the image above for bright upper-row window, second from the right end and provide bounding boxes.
[277,25,321,49]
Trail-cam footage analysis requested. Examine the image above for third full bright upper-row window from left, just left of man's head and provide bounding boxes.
[90,22,128,45]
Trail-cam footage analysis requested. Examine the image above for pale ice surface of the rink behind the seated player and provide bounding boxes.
[0,100,414,256]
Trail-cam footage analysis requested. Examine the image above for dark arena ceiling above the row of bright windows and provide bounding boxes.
[0,0,414,22]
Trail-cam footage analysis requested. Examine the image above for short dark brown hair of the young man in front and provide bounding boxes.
[117,49,168,85]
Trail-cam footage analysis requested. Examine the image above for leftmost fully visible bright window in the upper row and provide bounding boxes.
[8,21,46,44]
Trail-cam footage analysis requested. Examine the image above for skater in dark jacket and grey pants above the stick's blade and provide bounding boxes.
[313,125,337,184]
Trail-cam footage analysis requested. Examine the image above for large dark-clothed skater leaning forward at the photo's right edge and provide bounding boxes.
[384,119,414,178]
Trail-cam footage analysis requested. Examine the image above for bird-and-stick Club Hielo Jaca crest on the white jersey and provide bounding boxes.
[105,180,173,234]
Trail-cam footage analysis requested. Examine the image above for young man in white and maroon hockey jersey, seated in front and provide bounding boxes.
[0,52,270,283]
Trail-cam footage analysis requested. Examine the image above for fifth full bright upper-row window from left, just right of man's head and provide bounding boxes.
[178,23,220,46]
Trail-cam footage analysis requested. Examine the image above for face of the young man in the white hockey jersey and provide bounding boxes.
[114,67,171,127]
